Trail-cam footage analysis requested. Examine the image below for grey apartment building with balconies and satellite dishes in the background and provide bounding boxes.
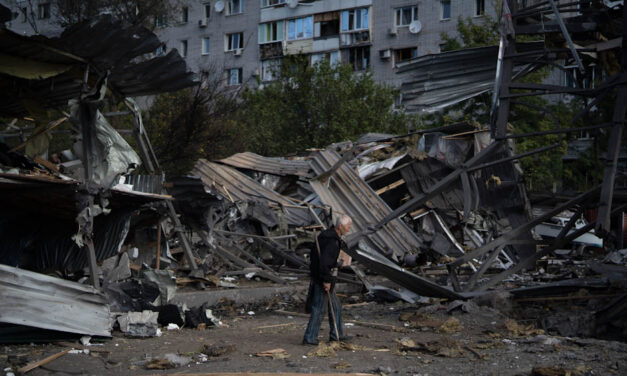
[156,0,495,85]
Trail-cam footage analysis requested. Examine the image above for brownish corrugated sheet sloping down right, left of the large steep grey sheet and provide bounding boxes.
[192,159,313,226]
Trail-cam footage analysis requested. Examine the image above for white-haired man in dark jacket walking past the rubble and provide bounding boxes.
[303,215,352,345]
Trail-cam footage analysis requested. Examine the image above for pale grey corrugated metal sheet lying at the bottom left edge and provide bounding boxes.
[0,264,111,337]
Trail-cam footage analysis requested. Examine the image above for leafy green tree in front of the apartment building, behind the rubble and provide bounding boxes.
[238,56,407,155]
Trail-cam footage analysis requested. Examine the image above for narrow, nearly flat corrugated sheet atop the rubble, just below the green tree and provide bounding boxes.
[219,152,313,178]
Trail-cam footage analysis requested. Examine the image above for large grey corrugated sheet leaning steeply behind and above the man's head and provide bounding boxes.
[311,150,422,260]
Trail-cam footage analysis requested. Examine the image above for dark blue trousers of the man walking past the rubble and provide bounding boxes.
[303,282,344,343]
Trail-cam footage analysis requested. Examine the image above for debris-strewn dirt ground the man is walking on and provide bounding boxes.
[0,296,627,376]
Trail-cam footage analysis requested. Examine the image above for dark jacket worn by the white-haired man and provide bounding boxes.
[309,227,341,283]
